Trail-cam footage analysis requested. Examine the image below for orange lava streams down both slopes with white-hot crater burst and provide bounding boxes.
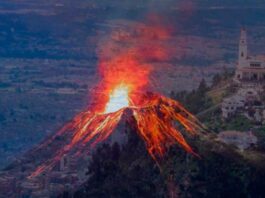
[30,84,202,178]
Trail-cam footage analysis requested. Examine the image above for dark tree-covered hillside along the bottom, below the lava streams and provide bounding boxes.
[59,124,265,198]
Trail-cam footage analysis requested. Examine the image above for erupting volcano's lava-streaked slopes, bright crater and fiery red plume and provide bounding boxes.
[30,18,202,177]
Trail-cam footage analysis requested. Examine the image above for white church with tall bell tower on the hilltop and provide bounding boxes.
[234,28,265,83]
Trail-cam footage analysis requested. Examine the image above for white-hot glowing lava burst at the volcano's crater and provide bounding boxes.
[104,84,130,113]
